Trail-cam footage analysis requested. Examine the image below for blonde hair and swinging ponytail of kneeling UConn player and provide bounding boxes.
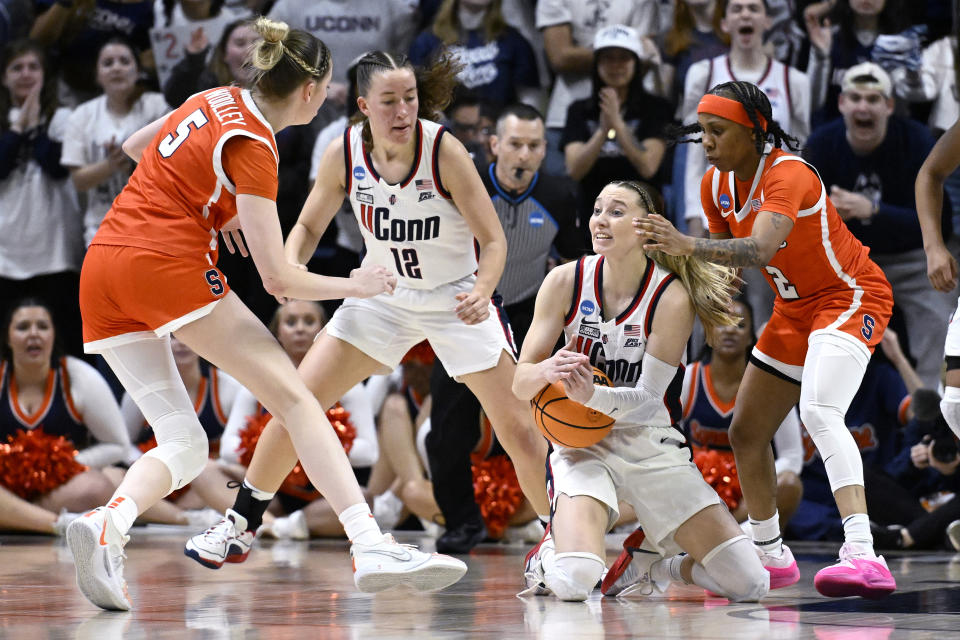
[610,180,740,336]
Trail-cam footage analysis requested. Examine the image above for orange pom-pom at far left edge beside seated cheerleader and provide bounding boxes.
[0,427,87,500]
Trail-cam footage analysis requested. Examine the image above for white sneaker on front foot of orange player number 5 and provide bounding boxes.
[350,533,467,593]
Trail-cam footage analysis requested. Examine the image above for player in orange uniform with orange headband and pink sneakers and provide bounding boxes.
[634,82,896,598]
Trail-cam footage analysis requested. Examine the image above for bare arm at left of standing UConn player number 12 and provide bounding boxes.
[284,136,346,264]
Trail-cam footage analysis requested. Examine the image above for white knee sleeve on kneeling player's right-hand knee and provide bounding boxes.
[693,536,770,602]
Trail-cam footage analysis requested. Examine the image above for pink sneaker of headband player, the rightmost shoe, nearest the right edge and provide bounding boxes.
[813,542,897,600]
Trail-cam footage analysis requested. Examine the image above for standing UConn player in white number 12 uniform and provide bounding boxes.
[187,51,549,564]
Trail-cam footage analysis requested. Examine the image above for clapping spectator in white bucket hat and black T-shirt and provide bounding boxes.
[560,24,673,246]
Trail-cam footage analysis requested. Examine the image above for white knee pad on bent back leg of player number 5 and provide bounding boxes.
[144,411,209,493]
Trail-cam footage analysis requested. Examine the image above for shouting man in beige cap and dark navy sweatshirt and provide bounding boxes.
[804,62,957,389]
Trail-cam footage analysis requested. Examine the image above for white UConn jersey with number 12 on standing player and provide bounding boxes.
[343,120,477,289]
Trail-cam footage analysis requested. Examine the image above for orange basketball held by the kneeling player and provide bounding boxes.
[530,367,614,448]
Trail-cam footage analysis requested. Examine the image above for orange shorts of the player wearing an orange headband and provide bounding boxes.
[755,261,893,367]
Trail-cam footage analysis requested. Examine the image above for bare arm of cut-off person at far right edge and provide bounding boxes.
[914,120,960,292]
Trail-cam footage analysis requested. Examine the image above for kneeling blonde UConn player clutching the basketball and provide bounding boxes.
[513,181,770,601]
